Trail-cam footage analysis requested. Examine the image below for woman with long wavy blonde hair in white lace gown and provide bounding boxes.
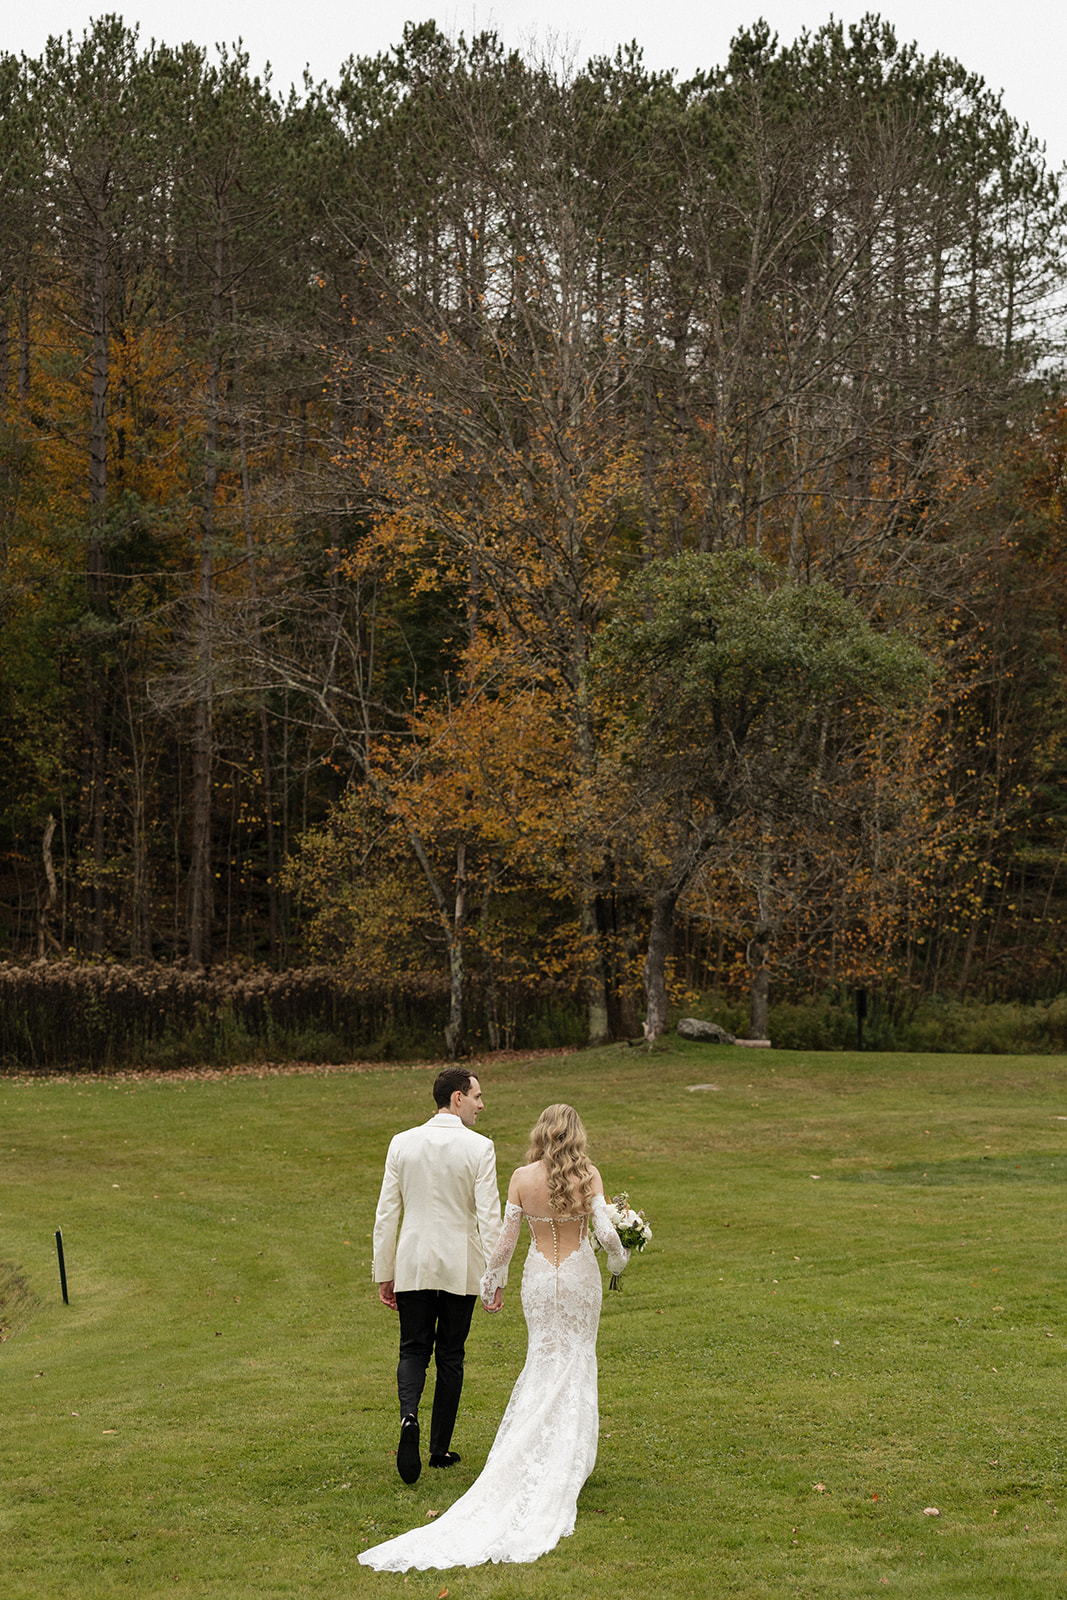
[360,1106,630,1573]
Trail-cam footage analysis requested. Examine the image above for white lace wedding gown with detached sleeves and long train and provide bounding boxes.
[360,1195,629,1573]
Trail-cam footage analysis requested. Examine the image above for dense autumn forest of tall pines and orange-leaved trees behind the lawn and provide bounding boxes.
[0,16,1067,1053]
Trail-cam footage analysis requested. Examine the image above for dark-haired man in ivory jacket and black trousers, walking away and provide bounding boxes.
[374,1067,501,1483]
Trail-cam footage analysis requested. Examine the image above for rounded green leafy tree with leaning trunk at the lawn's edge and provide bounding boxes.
[595,552,925,1040]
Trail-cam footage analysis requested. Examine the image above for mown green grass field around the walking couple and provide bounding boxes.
[0,1043,1067,1600]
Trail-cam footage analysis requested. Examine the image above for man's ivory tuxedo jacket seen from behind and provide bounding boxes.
[374,1115,501,1294]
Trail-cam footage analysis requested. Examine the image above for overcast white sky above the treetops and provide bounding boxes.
[8,0,1067,166]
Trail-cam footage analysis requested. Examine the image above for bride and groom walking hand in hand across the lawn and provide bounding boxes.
[360,1067,629,1571]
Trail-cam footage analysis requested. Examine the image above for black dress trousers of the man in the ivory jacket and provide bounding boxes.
[397,1290,477,1456]
